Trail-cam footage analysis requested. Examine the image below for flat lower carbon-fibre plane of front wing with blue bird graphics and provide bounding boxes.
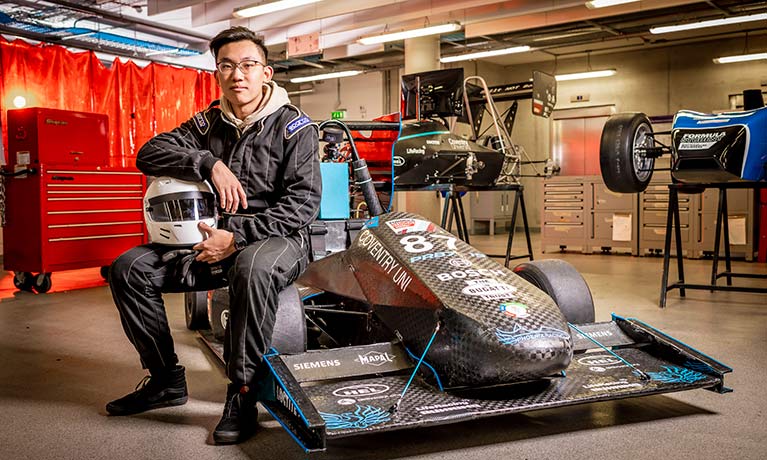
[294,349,719,438]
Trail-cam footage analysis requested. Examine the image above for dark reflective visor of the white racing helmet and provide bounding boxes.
[146,191,216,222]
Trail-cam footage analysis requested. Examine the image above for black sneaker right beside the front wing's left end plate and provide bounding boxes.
[213,383,258,444]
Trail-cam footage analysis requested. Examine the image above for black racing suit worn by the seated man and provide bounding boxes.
[110,103,322,385]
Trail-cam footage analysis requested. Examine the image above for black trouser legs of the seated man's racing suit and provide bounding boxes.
[109,234,308,384]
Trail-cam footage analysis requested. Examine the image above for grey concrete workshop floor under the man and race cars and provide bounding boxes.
[0,236,767,460]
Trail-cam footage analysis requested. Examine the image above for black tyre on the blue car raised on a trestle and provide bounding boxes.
[599,112,655,193]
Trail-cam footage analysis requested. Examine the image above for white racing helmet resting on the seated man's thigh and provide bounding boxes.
[144,176,217,246]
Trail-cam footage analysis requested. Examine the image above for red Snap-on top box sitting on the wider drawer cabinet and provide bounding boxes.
[8,107,109,169]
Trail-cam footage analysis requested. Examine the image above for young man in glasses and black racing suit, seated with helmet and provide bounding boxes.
[107,27,321,443]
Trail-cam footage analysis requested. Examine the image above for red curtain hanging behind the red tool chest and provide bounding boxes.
[0,37,219,166]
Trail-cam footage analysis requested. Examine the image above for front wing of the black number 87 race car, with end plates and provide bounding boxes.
[201,316,732,452]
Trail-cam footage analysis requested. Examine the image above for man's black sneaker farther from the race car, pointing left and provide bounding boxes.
[107,366,188,415]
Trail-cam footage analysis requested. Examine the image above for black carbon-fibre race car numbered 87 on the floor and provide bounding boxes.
[187,122,732,452]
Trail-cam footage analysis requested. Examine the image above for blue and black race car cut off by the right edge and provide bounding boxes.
[599,90,767,193]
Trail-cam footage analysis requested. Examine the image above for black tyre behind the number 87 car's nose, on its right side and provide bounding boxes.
[514,259,595,324]
